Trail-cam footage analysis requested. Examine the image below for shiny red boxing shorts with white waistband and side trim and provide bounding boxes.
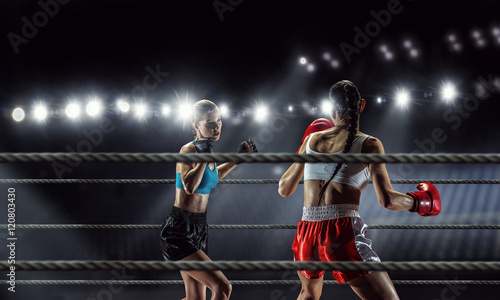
[292,204,380,283]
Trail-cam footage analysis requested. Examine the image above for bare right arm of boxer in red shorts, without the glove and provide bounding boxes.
[362,137,415,210]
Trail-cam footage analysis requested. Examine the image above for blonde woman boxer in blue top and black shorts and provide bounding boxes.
[160,100,257,300]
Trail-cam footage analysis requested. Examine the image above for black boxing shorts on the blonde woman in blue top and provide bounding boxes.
[160,206,208,261]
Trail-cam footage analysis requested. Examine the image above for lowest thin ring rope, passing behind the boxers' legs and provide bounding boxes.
[0,280,500,285]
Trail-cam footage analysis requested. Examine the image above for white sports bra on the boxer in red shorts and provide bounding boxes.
[304,133,370,190]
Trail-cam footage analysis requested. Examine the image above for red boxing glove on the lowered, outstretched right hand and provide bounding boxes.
[407,182,441,217]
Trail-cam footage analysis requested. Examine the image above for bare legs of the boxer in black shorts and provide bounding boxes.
[181,250,232,300]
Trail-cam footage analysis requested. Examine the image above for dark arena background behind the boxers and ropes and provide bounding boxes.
[0,0,500,300]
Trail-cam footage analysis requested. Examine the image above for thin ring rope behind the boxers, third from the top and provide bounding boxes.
[0,224,500,229]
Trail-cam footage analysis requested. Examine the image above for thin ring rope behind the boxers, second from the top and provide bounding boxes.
[0,179,500,184]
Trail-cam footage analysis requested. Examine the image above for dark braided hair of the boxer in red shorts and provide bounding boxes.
[318,80,361,205]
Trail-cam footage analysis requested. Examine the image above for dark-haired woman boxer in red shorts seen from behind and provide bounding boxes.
[279,80,441,300]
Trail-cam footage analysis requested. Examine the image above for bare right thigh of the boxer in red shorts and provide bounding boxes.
[347,272,399,300]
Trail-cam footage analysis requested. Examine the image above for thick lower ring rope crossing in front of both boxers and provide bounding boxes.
[0,260,500,271]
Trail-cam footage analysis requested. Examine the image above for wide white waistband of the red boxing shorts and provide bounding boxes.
[302,204,359,221]
